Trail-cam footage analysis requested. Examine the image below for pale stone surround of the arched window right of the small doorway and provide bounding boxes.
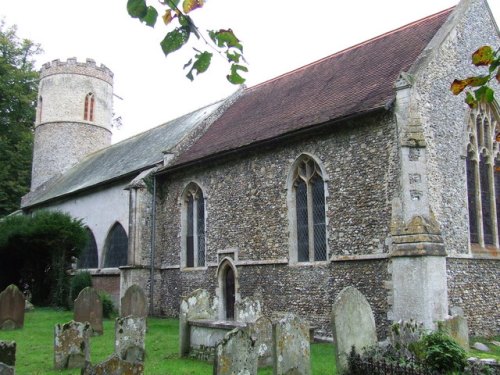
[287,152,330,266]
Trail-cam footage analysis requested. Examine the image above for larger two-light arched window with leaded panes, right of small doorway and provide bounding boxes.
[291,155,327,262]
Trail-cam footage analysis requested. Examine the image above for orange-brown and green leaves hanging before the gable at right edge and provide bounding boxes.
[450,46,500,108]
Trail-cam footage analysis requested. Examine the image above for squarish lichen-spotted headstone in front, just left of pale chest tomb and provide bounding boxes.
[115,316,146,363]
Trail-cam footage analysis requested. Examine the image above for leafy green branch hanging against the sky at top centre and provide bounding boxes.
[127,0,248,85]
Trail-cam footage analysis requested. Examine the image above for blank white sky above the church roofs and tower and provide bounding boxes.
[0,0,500,141]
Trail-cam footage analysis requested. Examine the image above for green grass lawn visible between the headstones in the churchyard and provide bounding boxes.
[0,308,335,375]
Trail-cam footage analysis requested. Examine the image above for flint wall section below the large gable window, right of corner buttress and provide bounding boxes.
[447,258,500,337]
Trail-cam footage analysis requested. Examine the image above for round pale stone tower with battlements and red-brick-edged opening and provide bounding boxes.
[31,58,113,191]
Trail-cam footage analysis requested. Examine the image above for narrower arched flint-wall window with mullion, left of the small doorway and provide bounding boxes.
[181,183,205,267]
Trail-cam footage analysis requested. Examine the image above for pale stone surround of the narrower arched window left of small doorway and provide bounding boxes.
[180,181,208,271]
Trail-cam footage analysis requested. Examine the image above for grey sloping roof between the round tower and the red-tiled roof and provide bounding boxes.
[22,101,223,207]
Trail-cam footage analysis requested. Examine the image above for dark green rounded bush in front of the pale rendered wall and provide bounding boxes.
[0,211,88,307]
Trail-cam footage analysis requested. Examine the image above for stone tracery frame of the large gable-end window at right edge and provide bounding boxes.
[465,103,500,252]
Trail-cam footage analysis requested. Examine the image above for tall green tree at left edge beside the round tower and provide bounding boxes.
[0,20,41,217]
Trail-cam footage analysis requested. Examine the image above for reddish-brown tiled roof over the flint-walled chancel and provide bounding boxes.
[175,8,452,165]
